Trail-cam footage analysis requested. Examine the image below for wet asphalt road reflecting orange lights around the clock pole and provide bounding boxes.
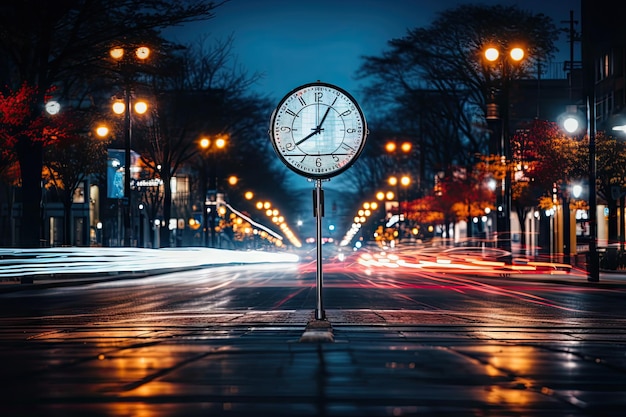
[0,263,626,417]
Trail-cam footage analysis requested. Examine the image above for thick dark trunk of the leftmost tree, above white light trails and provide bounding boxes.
[16,136,43,248]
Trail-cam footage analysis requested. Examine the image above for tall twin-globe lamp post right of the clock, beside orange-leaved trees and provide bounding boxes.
[484,47,525,253]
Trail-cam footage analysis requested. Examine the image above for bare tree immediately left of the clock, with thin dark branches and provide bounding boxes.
[136,37,290,245]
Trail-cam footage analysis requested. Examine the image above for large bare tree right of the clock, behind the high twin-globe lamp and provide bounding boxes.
[359,4,559,239]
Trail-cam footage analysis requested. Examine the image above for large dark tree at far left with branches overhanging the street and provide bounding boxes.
[0,0,224,246]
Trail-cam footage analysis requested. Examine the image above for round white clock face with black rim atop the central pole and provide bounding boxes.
[270,82,367,178]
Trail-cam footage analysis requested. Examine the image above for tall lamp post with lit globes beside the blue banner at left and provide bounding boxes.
[109,46,151,246]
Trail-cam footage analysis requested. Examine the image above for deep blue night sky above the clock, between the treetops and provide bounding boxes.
[167,0,580,100]
